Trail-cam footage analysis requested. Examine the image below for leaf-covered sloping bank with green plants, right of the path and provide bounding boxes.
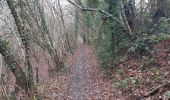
[112,39,170,100]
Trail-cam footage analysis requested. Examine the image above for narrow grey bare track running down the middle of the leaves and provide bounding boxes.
[69,46,87,100]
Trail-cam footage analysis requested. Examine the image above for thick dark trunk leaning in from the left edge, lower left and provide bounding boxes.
[0,38,29,92]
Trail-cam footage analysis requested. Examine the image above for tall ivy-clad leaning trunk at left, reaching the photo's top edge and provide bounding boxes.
[7,0,34,94]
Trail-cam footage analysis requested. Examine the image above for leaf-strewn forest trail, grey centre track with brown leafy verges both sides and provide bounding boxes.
[46,45,119,100]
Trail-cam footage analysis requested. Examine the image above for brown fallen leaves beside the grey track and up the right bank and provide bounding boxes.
[41,41,170,100]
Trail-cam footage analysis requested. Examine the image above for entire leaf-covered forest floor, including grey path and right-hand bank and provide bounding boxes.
[43,40,170,100]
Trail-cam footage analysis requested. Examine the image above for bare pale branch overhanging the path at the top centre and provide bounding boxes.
[67,0,113,18]
